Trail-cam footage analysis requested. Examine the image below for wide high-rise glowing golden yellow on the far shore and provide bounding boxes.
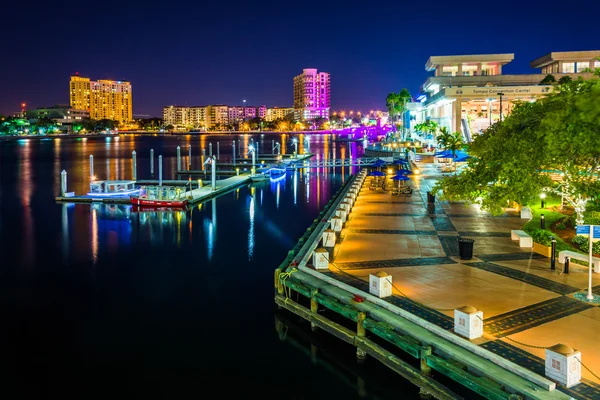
[69,75,133,123]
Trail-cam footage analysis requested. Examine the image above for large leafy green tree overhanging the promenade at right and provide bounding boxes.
[434,79,600,219]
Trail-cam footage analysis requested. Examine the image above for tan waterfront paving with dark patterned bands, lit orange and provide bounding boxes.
[328,158,600,399]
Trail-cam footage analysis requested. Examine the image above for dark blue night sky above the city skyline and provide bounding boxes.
[0,0,600,116]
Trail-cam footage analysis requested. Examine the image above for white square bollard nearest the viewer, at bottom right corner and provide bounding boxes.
[546,344,581,387]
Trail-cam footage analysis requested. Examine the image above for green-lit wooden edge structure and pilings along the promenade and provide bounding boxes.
[274,170,571,400]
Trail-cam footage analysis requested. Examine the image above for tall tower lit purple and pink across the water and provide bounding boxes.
[294,68,331,120]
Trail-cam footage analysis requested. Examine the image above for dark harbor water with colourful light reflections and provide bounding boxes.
[0,135,418,399]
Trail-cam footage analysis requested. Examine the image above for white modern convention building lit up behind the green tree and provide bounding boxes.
[409,51,600,140]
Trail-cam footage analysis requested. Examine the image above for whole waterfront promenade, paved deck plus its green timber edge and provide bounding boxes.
[274,164,600,400]
